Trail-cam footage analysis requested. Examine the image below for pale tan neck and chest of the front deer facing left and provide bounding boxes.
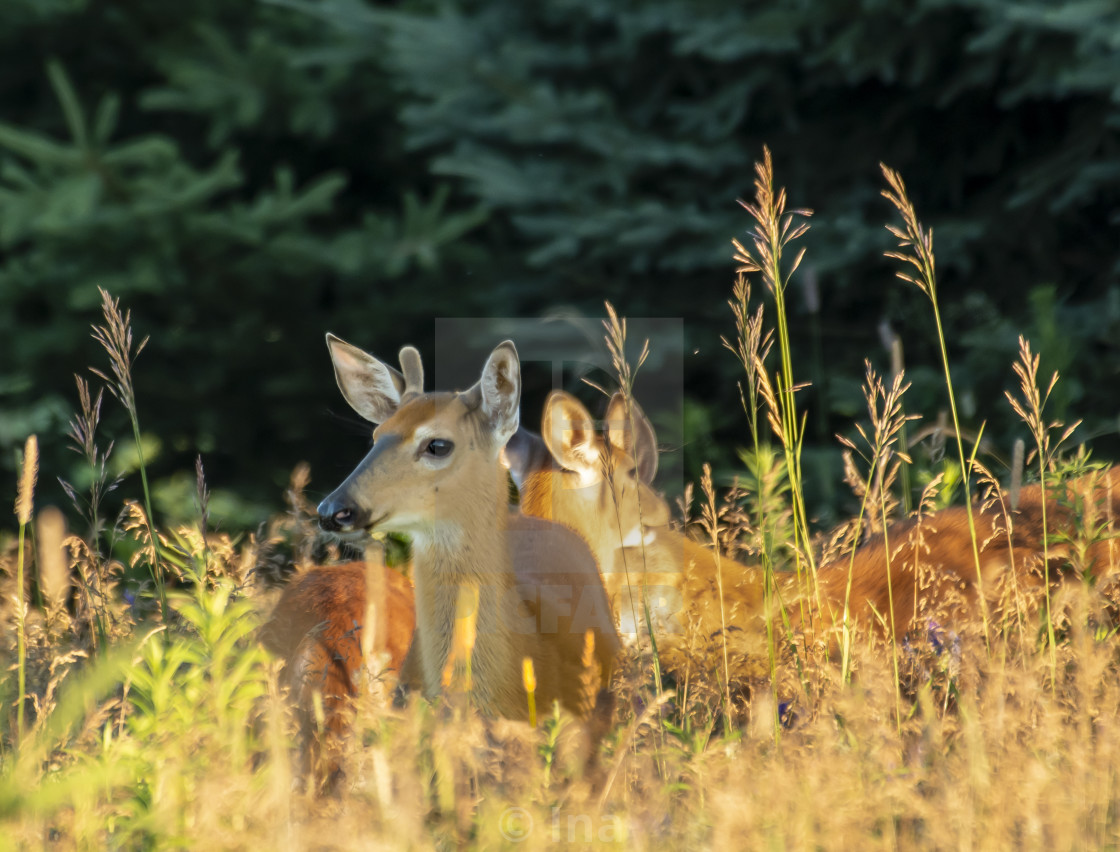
[412,465,520,709]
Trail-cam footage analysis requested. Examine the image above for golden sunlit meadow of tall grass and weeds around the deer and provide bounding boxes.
[0,153,1120,850]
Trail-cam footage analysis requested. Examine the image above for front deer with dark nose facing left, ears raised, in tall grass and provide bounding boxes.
[318,335,618,719]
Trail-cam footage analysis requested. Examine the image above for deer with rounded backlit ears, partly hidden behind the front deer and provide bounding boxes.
[505,391,768,677]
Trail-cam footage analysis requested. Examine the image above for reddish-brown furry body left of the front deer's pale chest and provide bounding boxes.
[260,562,416,780]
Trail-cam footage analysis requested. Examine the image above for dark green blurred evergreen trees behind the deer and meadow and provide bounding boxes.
[0,0,1120,527]
